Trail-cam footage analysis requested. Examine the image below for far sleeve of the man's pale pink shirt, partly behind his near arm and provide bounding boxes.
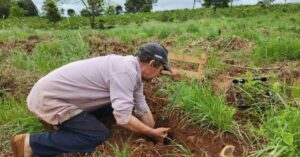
[133,83,150,117]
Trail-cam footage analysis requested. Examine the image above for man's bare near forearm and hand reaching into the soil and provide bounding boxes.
[123,115,170,138]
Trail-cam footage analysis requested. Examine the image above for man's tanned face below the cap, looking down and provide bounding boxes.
[142,61,164,81]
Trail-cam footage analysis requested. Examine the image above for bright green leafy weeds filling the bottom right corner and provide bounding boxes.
[253,107,300,157]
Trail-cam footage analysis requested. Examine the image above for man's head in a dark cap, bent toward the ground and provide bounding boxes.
[137,43,171,80]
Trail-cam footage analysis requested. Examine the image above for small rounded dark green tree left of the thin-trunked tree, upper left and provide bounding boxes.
[43,0,61,23]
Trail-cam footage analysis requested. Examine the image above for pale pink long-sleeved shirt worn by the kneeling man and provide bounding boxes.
[27,55,149,125]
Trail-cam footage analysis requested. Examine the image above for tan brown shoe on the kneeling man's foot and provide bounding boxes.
[11,134,28,157]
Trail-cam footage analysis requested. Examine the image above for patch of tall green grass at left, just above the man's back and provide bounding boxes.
[8,31,88,73]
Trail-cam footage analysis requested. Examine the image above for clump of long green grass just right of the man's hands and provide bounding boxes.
[163,81,237,133]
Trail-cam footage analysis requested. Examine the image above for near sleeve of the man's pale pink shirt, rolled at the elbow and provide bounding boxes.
[110,72,136,125]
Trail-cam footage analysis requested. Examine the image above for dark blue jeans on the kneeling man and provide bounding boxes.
[29,105,113,157]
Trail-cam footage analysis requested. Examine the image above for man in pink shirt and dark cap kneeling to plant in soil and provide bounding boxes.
[11,43,170,157]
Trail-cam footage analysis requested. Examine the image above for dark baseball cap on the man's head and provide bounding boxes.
[137,43,172,72]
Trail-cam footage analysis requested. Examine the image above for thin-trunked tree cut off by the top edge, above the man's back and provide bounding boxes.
[81,0,104,28]
